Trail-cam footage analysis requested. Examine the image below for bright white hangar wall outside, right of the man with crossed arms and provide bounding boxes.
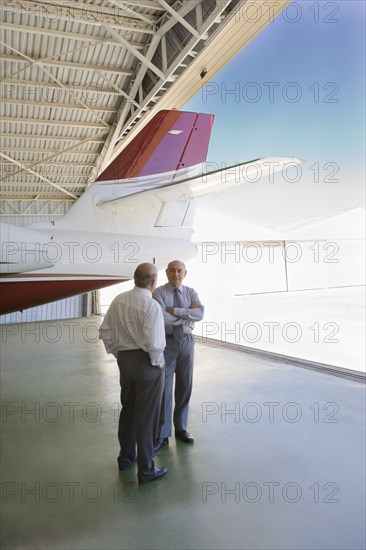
[188,239,365,296]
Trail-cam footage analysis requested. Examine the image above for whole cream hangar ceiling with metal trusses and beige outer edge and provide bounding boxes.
[0,0,289,218]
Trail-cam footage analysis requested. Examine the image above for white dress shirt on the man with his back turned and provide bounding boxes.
[99,286,166,368]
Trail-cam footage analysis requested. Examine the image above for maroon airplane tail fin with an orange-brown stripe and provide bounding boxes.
[96,110,214,183]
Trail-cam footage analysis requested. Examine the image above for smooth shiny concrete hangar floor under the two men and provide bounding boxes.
[1,318,365,550]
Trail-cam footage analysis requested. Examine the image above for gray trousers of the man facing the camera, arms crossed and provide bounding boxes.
[158,334,194,438]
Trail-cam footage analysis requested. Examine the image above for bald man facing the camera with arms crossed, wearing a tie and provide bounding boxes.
[153,260,204,452]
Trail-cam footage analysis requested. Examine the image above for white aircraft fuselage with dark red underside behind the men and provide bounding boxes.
[0,224,197,314]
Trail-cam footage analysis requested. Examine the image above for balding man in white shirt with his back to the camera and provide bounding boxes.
[99,263,167,483]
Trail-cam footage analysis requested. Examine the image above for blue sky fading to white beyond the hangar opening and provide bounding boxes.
[185,0,365,225]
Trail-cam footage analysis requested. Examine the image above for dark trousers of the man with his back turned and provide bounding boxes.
[117,349,164,477]
